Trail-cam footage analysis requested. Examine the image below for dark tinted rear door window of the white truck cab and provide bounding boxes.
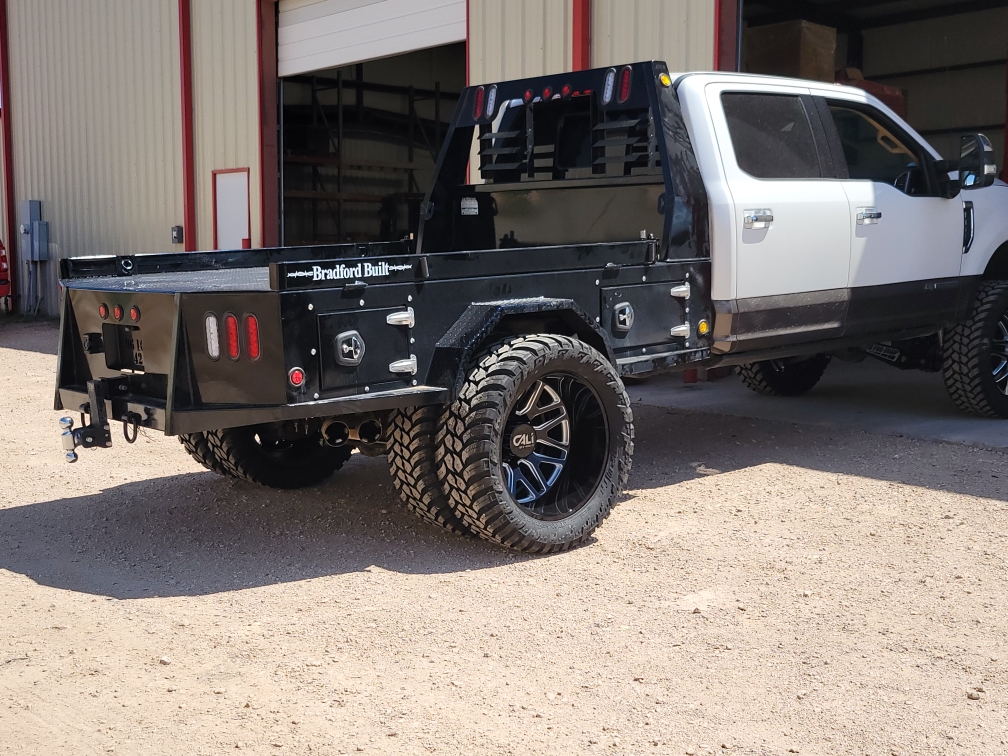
[721,92,822,178]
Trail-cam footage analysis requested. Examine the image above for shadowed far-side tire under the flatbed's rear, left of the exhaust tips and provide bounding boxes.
[207,425,353,489]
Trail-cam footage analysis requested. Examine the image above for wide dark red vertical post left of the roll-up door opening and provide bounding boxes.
[256,0,280,247]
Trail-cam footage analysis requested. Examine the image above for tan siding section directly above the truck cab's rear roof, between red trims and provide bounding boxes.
[592,0,715,72]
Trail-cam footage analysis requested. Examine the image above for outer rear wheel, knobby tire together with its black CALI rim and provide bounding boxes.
[436,335,634,553]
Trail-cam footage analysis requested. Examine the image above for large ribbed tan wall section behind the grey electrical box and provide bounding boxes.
[4,0,182,314]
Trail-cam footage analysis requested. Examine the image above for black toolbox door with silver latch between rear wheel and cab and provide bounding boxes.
[599,282,685,356]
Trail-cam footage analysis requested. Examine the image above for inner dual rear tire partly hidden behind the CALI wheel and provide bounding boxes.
[387,406,469,534]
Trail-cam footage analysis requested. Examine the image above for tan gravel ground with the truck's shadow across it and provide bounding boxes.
[0,324,1008,756]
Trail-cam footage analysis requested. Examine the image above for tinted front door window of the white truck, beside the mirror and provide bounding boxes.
[830,102,926,195]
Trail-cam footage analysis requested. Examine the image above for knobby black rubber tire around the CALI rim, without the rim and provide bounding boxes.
[436,335,634,553]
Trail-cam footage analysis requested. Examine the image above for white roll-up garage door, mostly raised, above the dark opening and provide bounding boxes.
[277,0,466,77]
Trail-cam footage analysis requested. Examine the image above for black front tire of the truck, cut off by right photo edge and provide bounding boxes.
[941,281,1008,417]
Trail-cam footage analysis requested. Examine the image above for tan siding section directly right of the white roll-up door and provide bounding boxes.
[469,0,574,84]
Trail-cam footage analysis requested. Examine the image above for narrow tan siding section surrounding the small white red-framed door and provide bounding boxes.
[191,0,262,249]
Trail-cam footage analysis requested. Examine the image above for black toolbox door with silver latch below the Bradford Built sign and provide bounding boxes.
[319,307,412,390]
